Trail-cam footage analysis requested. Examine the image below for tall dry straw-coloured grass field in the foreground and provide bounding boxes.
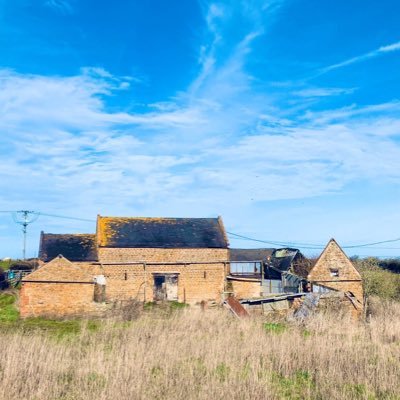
[0,302,400,400]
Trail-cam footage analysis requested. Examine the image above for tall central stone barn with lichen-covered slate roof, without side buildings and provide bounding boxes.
[97,216,228,303]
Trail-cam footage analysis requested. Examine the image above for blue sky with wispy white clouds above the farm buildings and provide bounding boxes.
[0,0,400,258]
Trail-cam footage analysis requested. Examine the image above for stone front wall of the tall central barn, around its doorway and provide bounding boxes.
[98,248,228,303]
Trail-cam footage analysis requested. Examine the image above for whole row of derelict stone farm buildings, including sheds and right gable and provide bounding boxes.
[20,216,363,317]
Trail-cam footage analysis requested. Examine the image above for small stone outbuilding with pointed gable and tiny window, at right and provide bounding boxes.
[308,239,364,305]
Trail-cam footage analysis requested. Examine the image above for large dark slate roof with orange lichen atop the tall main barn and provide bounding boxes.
[97,216,228,248]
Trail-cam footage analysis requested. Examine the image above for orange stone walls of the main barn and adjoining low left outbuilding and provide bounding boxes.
[20,248,228,317]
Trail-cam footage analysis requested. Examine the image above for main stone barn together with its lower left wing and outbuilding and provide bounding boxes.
[21,216,228,316]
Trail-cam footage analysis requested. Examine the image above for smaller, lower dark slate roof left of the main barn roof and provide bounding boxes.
[39,232,97,262]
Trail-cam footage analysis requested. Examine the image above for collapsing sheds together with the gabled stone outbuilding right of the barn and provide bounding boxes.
[227,239,363,319]
